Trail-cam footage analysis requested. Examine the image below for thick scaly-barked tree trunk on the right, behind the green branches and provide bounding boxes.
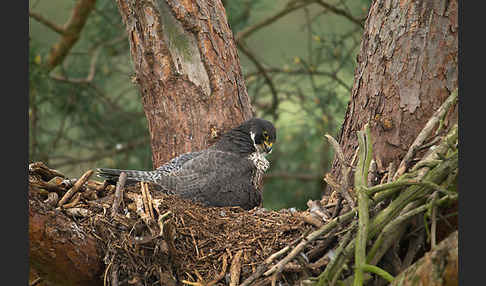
[331,0,458,183]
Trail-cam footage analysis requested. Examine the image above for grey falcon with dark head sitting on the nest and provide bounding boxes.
[97,118,276,210]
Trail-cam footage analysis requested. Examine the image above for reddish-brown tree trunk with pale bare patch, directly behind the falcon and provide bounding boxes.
[117,0,252,167]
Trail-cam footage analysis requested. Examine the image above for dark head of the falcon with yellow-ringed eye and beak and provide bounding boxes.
[247,118,277,155]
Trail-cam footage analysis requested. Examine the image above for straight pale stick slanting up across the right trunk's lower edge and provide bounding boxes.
[393,90,457,180]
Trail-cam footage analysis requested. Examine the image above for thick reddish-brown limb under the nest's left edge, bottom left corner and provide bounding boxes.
[29,200,104,285]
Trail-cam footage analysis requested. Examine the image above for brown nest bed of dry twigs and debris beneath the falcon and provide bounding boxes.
[29,162,346,285]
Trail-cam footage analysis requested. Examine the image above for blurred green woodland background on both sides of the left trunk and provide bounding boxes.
[29,0,371,209]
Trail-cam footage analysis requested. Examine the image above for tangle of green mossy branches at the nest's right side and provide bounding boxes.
[316,122,458,285]
